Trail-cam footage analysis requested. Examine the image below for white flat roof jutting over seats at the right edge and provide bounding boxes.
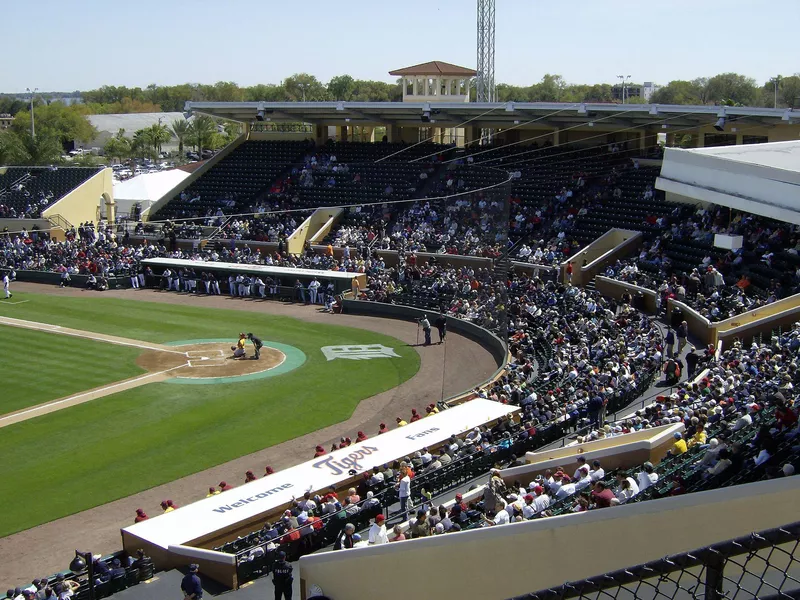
[656,141,800,225]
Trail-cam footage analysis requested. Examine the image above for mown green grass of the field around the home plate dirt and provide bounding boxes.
[0,294,419,537]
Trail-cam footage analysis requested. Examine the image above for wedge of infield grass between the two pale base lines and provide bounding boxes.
[0,325,145,415]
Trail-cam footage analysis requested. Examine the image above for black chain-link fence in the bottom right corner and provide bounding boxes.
[512,520,800,600]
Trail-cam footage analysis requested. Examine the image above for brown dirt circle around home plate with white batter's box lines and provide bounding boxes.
[136,342,286,379]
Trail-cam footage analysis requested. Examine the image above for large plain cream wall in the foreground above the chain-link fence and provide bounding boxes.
[299,477,800,600]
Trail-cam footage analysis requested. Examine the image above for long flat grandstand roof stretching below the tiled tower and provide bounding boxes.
[185,101,800,128]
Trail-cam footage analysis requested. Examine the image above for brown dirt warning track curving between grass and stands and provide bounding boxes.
[0,282,497,587]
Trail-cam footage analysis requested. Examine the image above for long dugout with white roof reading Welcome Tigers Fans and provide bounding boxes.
[121,399,519,589]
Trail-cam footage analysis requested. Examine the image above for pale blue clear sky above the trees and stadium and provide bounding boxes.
[0,0,800,92]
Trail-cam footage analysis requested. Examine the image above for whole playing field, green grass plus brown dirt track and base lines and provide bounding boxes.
[0,283,496,579]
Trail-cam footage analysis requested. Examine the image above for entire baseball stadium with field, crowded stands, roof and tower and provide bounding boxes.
[0,0,800,600]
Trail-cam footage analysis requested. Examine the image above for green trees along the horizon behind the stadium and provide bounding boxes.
[0,73,800,165]
